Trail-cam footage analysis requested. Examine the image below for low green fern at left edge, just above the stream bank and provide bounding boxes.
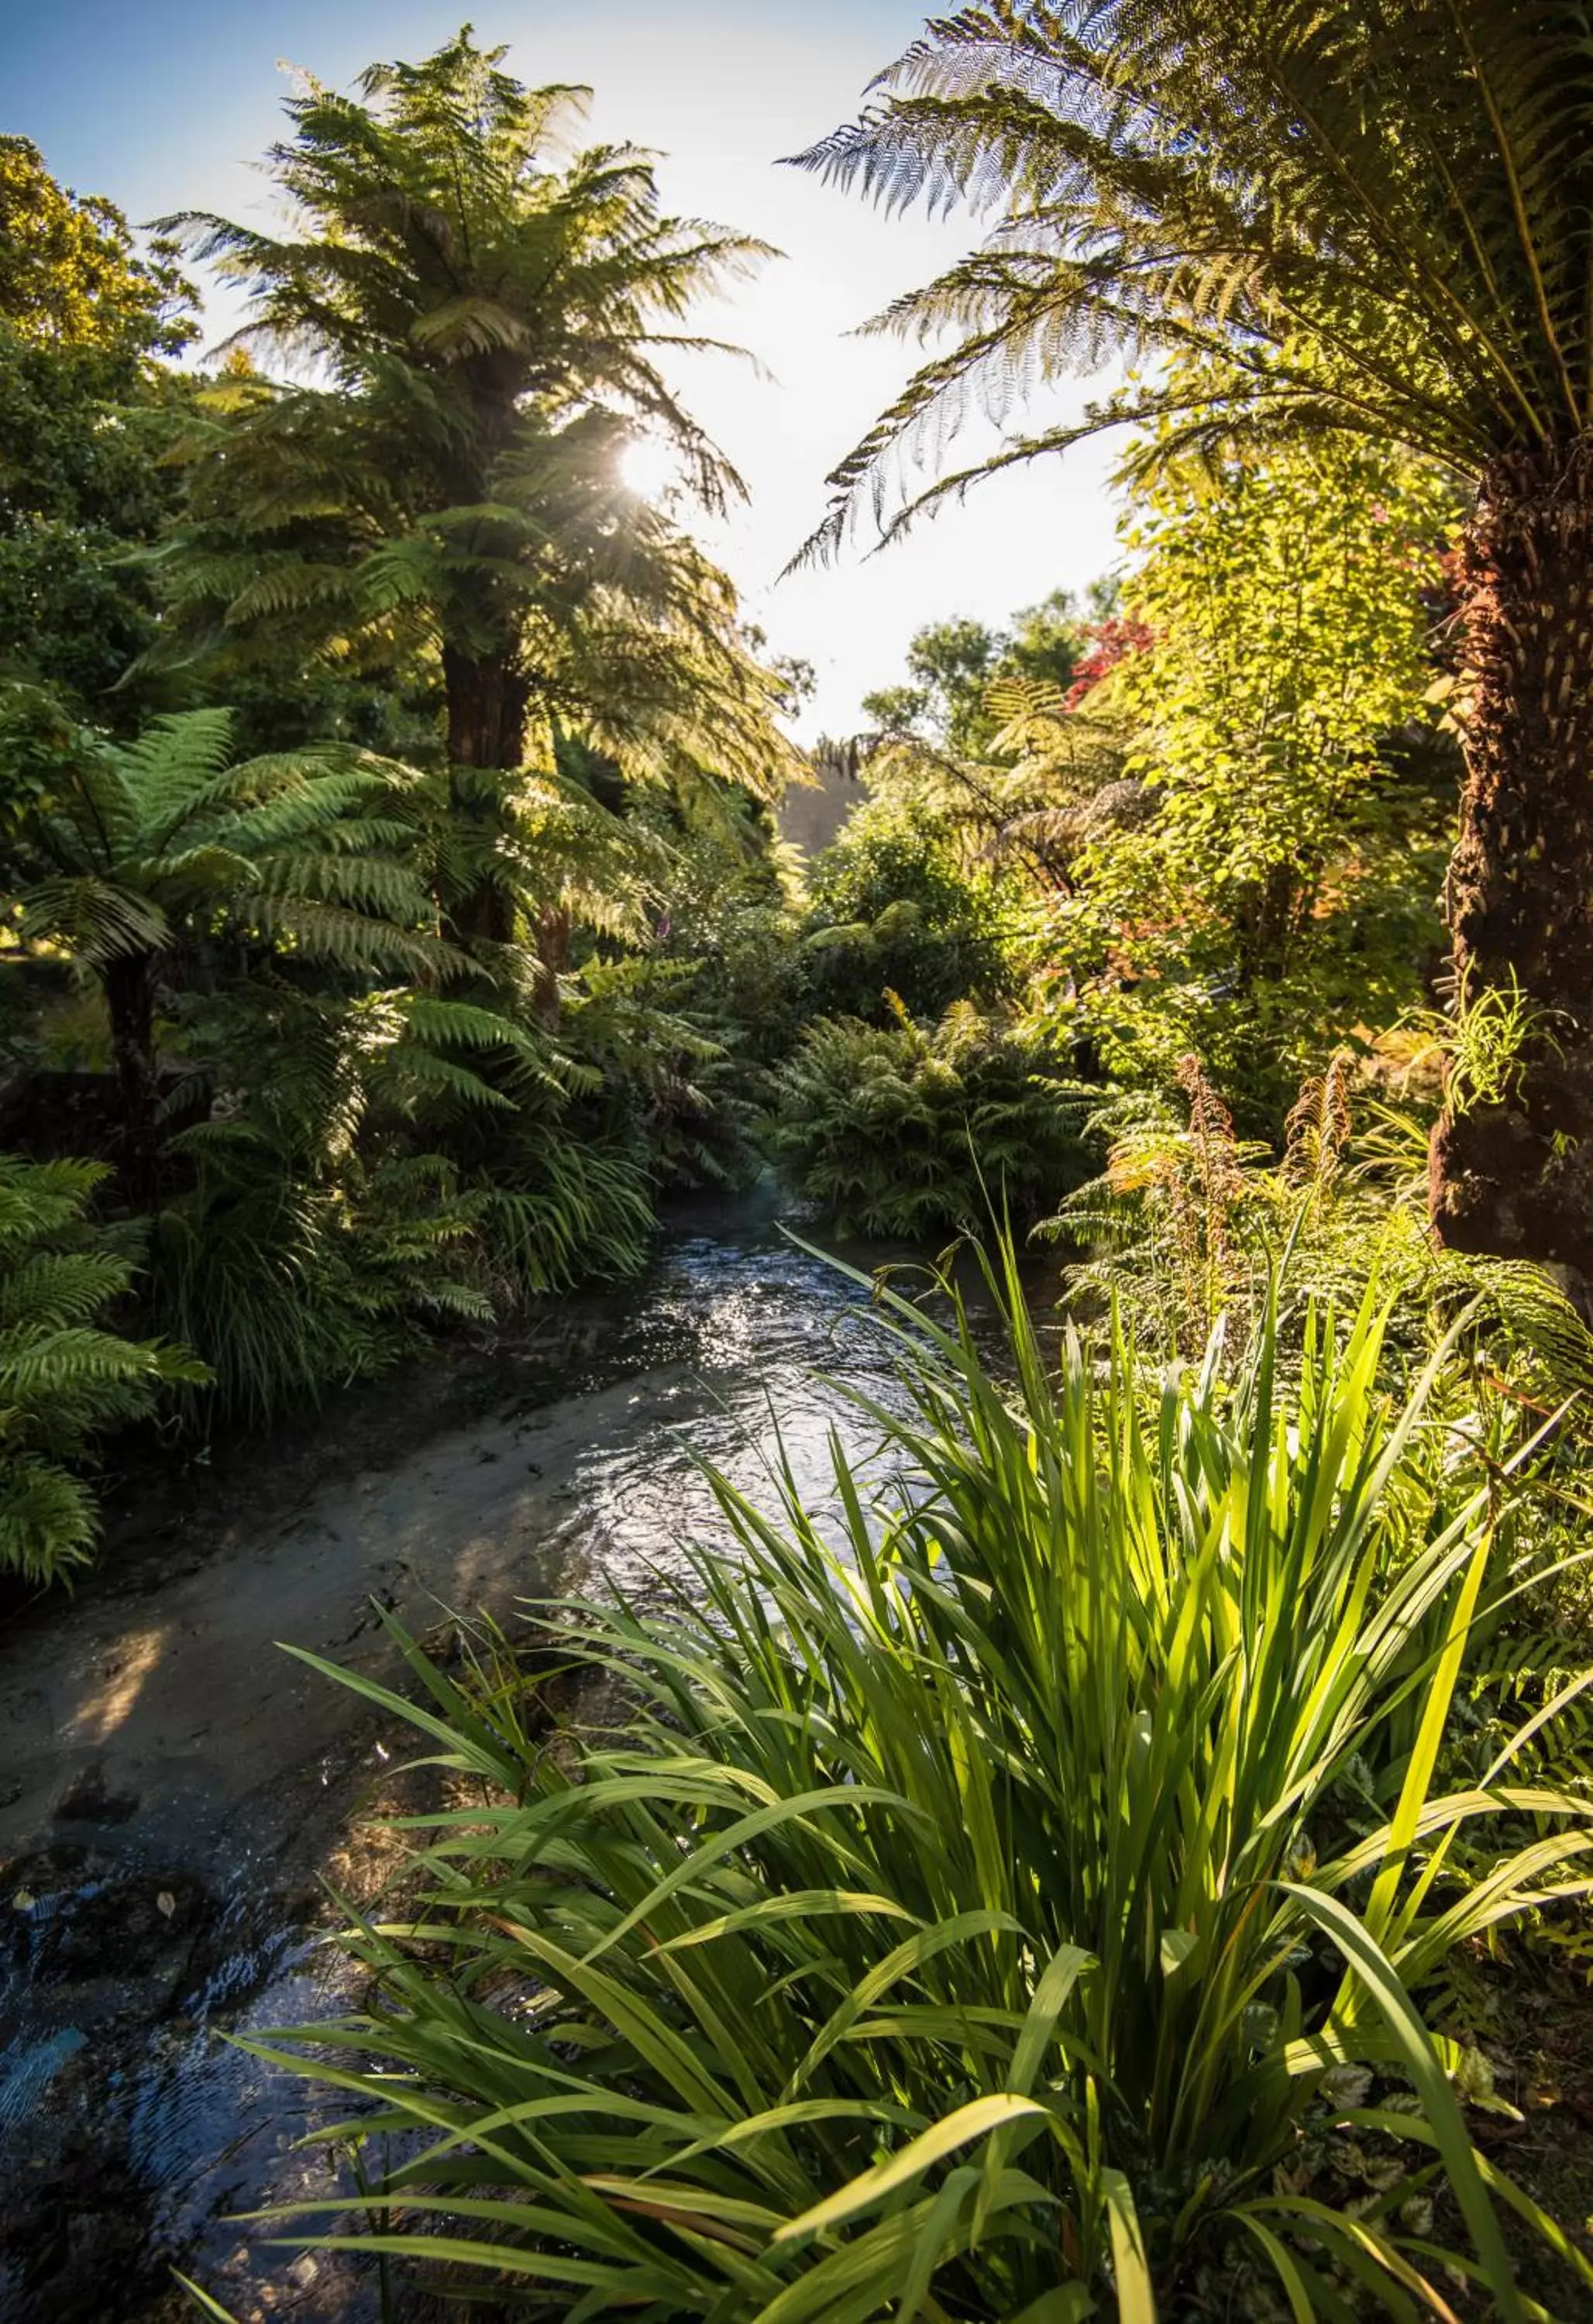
[0,1155,209,1583]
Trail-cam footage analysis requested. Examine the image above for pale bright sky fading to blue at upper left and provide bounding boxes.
[0,0,1116,734]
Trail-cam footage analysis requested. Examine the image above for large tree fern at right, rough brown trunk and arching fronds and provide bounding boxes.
[800,0,1593,1278]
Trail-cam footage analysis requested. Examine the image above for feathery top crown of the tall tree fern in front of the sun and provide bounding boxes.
[163,33,769,504]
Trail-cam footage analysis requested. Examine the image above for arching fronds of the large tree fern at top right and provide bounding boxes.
[798,0,1593,551]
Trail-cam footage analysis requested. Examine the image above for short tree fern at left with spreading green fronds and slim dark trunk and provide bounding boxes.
[0,700,449,1181]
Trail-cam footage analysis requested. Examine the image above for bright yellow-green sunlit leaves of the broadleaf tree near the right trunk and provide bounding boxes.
[1098,444,1451,939]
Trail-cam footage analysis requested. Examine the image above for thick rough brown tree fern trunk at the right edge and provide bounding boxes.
[1430,437,1593,1285]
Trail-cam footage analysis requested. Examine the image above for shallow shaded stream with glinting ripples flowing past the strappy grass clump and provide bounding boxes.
[0,1195,1032,2324]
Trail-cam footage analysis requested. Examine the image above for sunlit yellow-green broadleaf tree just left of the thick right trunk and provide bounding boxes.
[1065,437,1456,1136]
